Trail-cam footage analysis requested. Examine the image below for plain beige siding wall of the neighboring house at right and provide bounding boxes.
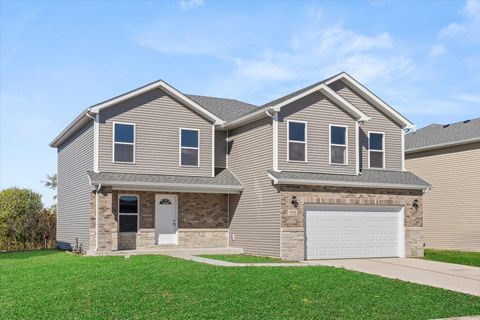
[406,143,480,251]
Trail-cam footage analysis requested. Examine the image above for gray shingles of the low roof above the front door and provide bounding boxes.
[88,168,242,188]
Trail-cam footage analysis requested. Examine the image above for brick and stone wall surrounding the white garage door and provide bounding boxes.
[279,185,423,260]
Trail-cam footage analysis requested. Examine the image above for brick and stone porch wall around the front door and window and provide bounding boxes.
[90,188,228,251]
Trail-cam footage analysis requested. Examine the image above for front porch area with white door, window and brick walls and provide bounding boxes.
[89,187,234,254]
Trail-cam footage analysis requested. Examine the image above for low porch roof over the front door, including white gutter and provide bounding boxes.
[88,168,243,193]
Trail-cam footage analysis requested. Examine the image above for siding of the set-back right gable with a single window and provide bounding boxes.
[330,80,403,171]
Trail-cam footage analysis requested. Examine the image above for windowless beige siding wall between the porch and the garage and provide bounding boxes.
[228,118,280,257]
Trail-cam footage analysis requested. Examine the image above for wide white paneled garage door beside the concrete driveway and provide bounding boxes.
[305,206,404,259]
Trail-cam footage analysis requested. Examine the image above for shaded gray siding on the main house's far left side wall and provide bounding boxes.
[57,121,93,250]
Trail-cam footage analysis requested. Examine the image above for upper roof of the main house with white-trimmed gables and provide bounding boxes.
[50,72,413,147]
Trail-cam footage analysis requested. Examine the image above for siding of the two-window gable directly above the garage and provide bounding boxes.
[278,92,356,174]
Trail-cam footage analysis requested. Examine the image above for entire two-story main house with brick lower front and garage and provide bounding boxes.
[51,73,429,260]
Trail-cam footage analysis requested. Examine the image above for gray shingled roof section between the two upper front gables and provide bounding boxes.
[186,94,258,121]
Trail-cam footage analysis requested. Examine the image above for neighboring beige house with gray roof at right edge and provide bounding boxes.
[405,118,480,251]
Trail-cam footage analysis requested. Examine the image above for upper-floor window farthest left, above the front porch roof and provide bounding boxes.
[113,122,135,163]
